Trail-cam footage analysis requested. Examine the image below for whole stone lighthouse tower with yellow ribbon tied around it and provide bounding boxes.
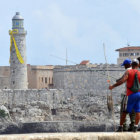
[9,12,28,89]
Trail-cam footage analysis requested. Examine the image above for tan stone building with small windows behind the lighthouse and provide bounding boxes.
[0,64,54,89]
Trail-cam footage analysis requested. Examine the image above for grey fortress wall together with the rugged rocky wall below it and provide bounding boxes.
[0,65,125,132]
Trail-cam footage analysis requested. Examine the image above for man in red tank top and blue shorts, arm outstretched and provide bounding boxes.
[109,59,140,132]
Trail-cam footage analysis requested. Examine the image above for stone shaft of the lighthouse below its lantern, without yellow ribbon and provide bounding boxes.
[10,30,28,89]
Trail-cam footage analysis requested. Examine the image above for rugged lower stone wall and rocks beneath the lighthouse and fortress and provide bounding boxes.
[0,89,126,133]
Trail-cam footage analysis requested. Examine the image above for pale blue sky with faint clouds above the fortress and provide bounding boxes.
[0,0,140,66]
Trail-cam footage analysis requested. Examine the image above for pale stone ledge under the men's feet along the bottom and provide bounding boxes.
[0,132,140,140]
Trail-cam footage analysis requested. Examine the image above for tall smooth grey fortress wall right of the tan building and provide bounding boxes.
[53,64,124,91]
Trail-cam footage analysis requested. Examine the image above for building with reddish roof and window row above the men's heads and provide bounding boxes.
[116,46,140,65]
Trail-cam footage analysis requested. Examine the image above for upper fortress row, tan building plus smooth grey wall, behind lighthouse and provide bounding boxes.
[0,64,124,89]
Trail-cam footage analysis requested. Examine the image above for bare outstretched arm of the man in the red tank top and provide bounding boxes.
[109,71,129,90]
